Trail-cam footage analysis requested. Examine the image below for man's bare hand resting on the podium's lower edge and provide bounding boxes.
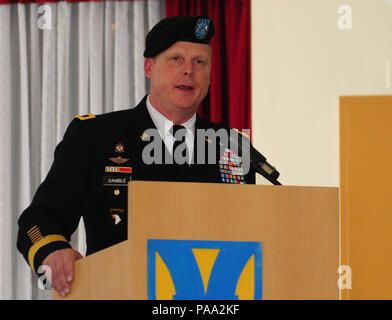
[42,249,83,297]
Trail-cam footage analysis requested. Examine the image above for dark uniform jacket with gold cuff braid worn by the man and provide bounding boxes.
[17,97,255,271]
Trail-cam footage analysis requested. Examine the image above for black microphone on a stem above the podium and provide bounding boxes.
[214,122,282,185]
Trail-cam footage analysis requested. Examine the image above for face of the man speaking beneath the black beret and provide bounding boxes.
[144,41,211,119]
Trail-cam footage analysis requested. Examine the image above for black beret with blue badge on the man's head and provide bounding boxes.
[144,16,215,58]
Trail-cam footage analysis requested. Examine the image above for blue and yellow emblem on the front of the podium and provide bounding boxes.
[147,240,262,300]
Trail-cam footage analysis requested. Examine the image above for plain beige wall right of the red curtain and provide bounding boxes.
[252,0,392,186]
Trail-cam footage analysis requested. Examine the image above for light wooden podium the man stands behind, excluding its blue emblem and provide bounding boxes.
[53,181,339,299]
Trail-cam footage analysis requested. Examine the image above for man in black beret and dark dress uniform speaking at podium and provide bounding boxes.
[17,16,255,296]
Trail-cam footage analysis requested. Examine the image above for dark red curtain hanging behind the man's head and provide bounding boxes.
[166,0,251,130]
